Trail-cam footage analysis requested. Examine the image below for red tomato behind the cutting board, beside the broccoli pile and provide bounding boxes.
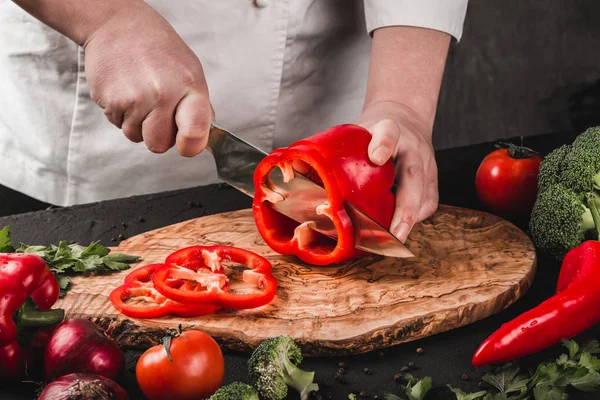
[475,144,543,218]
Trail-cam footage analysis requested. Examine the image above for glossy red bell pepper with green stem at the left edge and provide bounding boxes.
[0,253,64,379]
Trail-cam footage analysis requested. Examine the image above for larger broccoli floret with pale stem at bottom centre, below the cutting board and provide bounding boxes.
[248,336,319,400]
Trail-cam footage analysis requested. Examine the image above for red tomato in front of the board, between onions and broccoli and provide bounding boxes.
[135,330,225,400]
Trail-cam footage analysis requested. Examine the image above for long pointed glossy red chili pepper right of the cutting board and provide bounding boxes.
[472,240,600,366]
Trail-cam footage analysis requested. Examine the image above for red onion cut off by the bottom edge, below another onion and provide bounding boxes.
[38,374,129,400]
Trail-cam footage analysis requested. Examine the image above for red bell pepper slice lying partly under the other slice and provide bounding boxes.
[109,264,221,318]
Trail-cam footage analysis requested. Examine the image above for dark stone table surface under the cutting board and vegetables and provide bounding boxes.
[0,130,600,400]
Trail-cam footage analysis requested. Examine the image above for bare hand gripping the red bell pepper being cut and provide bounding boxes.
[355,101,438,242]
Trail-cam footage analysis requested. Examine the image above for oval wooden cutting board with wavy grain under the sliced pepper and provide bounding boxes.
[57,206,536,356]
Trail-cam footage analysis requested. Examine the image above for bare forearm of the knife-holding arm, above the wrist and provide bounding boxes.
[13,0,144,46]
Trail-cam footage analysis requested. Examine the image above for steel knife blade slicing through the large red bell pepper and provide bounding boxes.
[206,123,414,258]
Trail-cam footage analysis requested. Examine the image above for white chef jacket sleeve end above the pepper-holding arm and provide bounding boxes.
[365,0,468,41]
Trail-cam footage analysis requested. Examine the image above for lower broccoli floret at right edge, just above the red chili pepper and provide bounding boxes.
[529,184,600,259]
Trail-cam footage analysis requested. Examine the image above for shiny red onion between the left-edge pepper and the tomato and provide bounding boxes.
[44,319,125,382]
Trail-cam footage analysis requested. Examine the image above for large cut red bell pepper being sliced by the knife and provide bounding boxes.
[252,124,395,265]
